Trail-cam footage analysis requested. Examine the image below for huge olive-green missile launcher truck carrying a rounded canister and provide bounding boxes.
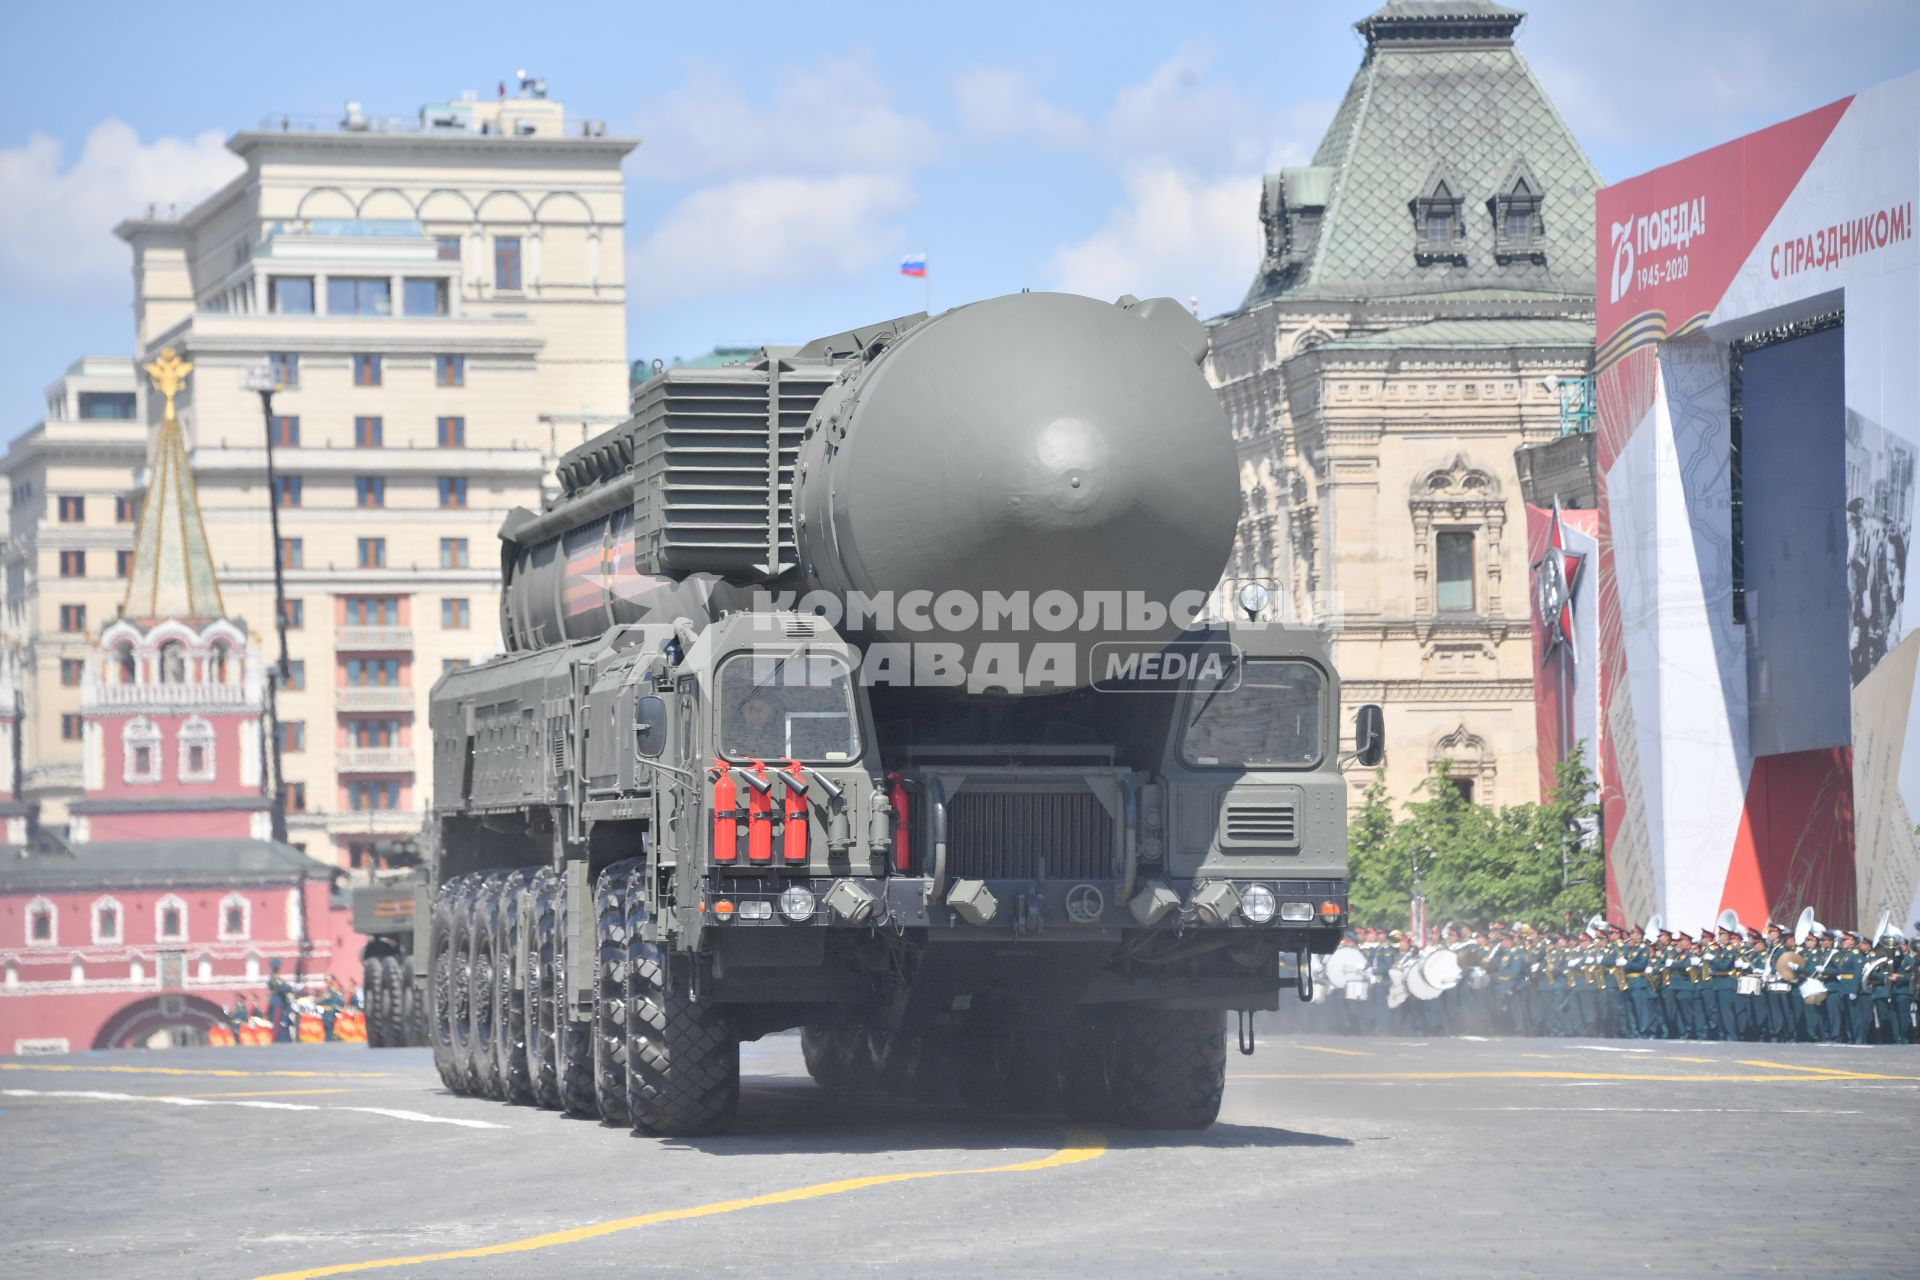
[415,294,1380,1136]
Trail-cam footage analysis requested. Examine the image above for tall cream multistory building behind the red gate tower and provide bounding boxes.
[8,81,636,865]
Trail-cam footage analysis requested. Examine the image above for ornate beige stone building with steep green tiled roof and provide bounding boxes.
[1208,0,1599,804]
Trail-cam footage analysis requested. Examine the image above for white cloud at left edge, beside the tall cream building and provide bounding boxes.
[0,119,246,299]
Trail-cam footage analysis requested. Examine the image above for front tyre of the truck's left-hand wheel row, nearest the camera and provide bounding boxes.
[626,901,739,1138]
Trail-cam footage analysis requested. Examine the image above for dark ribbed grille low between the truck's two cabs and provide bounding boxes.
[947,791,1114,881]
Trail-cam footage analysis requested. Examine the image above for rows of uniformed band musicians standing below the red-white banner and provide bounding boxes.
[1290,919,1920,1044]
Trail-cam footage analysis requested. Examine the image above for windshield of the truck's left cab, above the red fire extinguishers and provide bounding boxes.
[718,649,860,762]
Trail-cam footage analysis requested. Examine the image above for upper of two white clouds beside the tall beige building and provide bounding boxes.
[630,59,939,182]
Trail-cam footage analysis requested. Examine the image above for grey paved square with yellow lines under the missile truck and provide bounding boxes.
[0,1036,1920,1280]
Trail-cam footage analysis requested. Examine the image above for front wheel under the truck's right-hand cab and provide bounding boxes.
[1104,1007,1227,1128]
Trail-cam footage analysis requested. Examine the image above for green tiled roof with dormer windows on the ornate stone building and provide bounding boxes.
[1246,0,1599,305]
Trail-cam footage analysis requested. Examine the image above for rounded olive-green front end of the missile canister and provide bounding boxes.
[799,294,1238,683]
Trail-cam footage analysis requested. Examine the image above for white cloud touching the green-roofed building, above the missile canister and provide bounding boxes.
[1046,165,1261,315]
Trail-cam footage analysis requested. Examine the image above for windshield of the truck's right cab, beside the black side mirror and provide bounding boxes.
[1181,658,1327,770]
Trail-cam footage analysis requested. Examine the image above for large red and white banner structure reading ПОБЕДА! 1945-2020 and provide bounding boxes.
[1596,75,1920,929]
